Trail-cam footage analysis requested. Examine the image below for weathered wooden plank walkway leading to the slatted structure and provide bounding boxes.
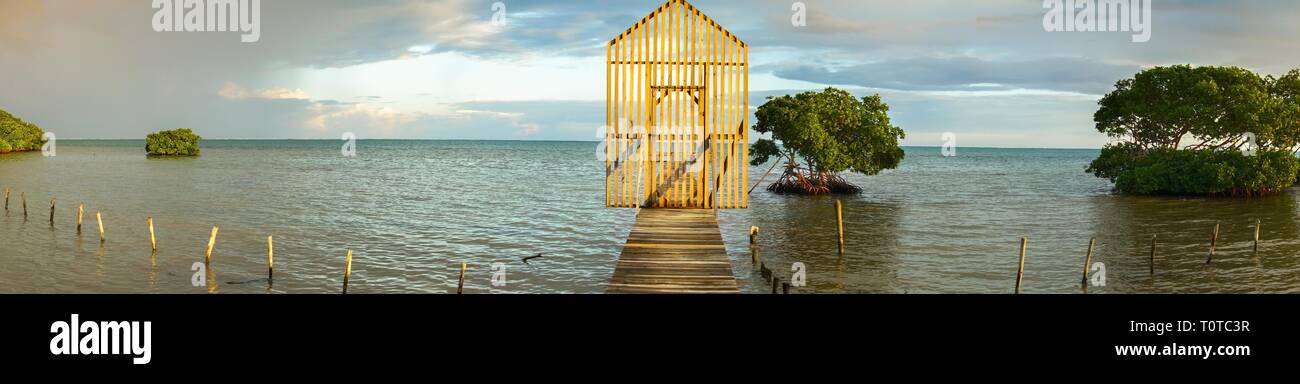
[606,208,740,293]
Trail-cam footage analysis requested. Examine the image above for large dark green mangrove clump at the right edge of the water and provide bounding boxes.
[1087,65,1300,197]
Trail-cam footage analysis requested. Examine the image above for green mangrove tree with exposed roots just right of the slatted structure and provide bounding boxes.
[750,87,905,194]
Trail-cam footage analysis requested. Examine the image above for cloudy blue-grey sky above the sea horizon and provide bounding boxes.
[0,0,1300,148]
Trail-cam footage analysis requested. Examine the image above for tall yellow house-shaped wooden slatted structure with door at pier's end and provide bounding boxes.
[605,0,749,208]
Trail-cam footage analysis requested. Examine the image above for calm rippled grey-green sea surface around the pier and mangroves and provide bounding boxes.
[0,139,1300,293]
